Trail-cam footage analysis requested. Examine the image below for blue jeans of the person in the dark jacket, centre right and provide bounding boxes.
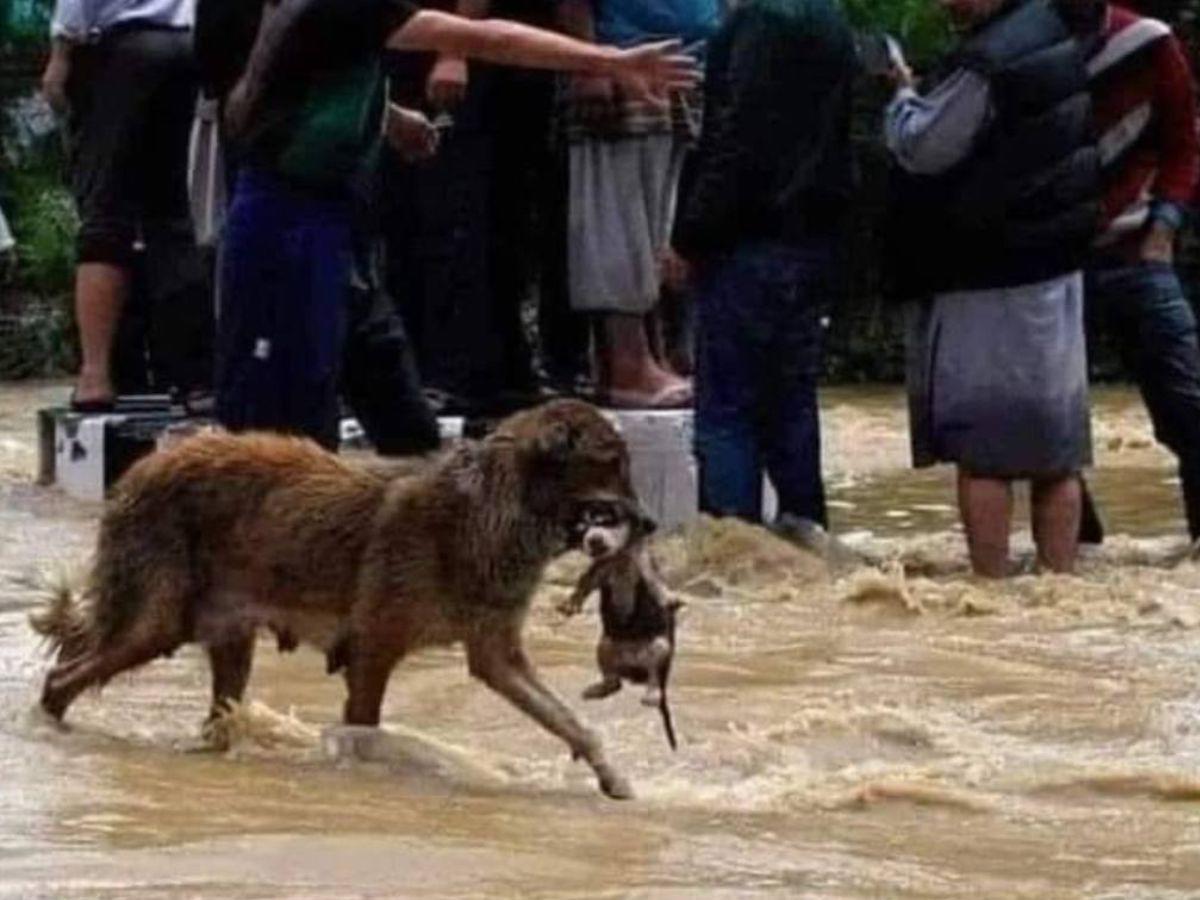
[696,240,834,524]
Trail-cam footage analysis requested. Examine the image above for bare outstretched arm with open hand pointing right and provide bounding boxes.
[388,10,700,100]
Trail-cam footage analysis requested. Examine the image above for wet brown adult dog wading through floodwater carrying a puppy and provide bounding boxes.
[34,401,635,797]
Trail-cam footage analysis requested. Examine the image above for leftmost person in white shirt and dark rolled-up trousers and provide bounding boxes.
[42,0,199,412]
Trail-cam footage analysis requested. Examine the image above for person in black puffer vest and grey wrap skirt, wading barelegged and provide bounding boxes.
[884,0,1098,577]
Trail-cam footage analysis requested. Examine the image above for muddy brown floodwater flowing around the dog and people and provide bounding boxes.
[0,385,1200,900]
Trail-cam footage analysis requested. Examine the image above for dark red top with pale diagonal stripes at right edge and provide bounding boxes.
[1087,6,1200,248]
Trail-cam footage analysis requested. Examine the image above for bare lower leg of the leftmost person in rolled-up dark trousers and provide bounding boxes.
[76,263,130,401]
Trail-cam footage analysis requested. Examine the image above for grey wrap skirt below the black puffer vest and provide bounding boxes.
[908,272,1092,479]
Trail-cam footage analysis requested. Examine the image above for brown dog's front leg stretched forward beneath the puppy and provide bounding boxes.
[467,635,634,800]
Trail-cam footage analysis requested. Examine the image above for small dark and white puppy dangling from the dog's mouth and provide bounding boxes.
[559,500,683,750]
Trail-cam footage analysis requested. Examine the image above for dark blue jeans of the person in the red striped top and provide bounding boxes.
[1086,260,1200,539]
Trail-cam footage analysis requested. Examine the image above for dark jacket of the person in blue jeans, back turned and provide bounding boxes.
[674,0,854,259]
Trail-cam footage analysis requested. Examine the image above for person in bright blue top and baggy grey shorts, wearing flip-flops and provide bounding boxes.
[563,0,719,408]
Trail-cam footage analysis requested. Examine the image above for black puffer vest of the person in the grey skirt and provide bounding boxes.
[894,0,1099,294]
